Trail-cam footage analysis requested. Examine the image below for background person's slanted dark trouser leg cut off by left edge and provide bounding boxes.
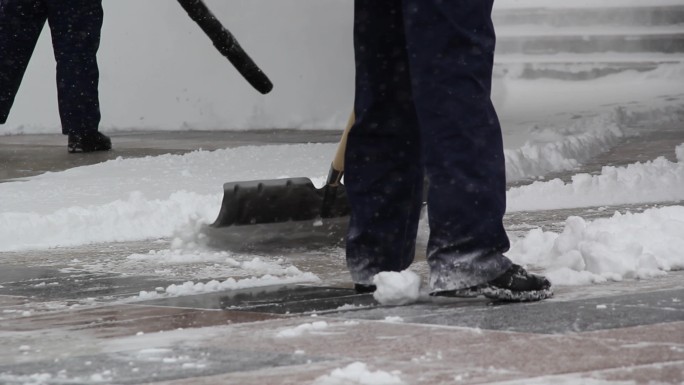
[0,0,47,124]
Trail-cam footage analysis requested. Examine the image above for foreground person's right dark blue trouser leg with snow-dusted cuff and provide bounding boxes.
[403,0,511,290]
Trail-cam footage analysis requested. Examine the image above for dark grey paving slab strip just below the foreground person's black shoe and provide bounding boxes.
[328,289,684,334]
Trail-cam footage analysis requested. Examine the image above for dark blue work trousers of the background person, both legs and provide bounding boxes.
[0,0,103,134]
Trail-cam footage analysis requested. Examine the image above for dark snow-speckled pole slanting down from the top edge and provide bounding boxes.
[178,0,273,94]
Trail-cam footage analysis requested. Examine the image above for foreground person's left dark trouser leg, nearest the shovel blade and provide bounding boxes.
[345,0,423,284]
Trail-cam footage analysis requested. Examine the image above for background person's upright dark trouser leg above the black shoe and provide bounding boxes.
[44,0,103,135]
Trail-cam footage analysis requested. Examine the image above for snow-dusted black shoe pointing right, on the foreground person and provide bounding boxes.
[482,264,553,302]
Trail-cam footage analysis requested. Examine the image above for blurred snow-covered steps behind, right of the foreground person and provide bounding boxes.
[494,0,684,80]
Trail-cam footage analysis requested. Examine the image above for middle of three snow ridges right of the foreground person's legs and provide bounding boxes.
[508,144,684,211]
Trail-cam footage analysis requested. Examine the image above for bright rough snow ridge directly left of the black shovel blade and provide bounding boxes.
[0,191,216,251]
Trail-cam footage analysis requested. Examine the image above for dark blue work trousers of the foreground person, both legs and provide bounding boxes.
[345,0,511,290]
